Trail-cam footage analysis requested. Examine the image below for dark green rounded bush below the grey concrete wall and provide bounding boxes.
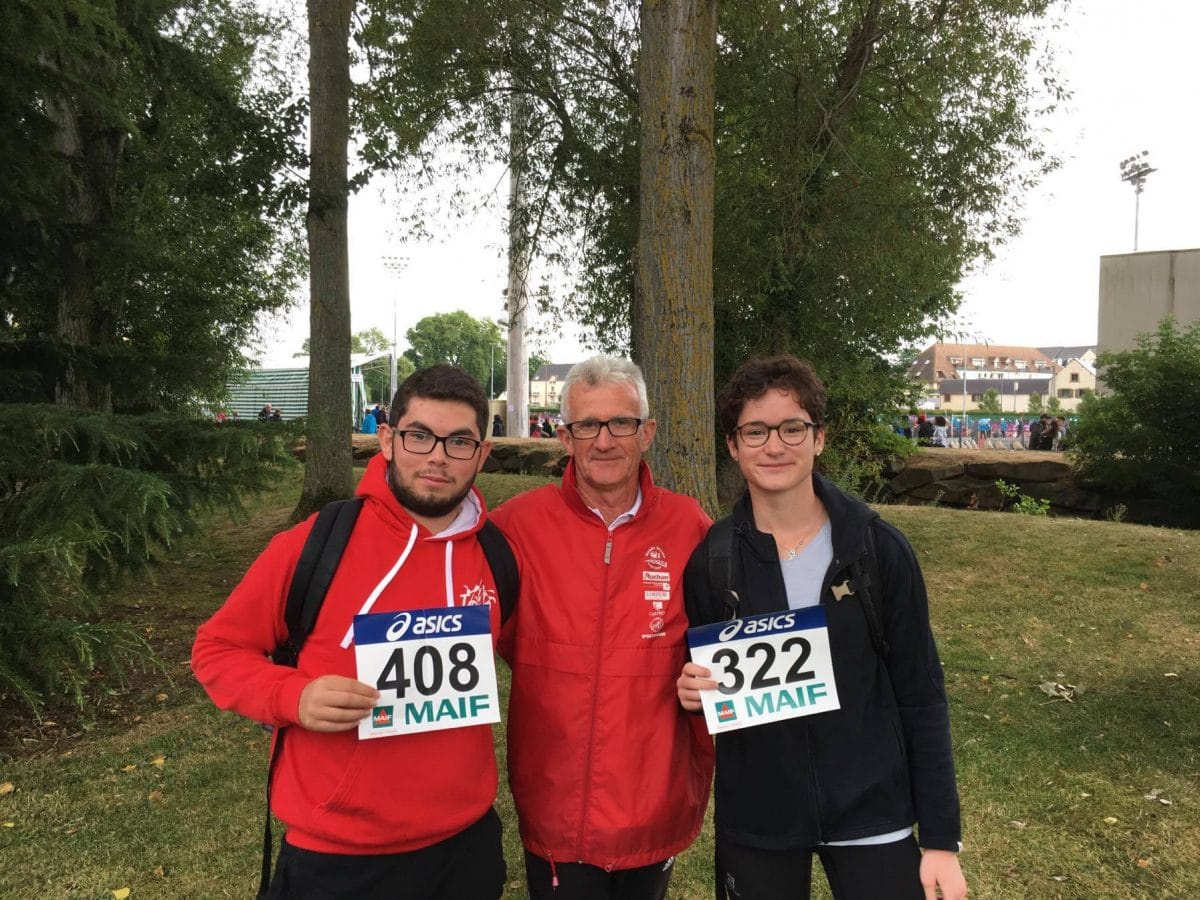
[1070,318,1200,526]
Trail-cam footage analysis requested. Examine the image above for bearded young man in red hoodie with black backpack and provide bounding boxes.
[192,366,505,900]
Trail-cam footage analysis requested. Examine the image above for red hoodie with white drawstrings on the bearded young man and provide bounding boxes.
[192,456,499,854]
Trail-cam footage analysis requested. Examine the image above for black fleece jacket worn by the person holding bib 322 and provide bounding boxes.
[684,475,960,851]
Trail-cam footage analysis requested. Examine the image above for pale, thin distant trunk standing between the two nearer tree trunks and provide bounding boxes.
[504,92,530,438]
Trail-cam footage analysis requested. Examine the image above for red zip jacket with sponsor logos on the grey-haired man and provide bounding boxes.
[492,463,713,869]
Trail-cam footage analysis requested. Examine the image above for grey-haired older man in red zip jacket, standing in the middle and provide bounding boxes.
[493,356,713,900]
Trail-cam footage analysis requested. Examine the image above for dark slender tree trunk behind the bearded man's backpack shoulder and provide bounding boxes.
[294,0,354,518]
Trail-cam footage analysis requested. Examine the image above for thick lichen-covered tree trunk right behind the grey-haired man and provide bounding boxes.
[632,0,718,515]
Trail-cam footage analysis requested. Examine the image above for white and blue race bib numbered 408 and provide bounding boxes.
[354,606,500,740]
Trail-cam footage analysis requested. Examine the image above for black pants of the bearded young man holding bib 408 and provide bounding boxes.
[266,809,506,900]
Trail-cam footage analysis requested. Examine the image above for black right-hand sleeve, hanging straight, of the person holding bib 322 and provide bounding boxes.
[876,522,962,851]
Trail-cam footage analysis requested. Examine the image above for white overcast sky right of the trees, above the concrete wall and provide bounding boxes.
[960,0,1200,347]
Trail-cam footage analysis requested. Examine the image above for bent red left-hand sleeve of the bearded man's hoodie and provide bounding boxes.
[192,523,311,725]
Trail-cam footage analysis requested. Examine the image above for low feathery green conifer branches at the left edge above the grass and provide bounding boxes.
[0,404,297,710]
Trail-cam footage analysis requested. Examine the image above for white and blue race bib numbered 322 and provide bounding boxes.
[688,606,840,734]
